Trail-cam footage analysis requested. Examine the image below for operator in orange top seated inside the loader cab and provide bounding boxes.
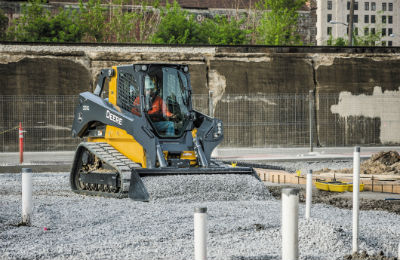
[132,75,176,136]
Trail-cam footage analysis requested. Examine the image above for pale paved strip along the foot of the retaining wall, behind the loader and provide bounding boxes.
[0,146,400,167]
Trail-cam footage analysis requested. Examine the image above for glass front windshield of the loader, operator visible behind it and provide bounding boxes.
[144,67,189,137]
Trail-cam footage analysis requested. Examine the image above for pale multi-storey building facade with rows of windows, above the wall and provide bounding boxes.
[317,0,400,46]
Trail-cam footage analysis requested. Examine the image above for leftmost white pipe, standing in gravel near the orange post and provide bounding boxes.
[22,168,32,226]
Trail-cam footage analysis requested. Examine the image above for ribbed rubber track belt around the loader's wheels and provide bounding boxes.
[74,142,141,198]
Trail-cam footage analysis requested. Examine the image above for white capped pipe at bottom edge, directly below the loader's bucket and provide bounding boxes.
[194,208,207,260]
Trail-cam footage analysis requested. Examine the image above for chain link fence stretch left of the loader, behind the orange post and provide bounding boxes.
[0,96,80,152]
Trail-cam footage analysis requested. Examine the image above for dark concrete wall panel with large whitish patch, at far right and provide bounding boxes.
[316,54,400,146]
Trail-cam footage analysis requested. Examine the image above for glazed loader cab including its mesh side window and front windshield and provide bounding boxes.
[116,64,192,139]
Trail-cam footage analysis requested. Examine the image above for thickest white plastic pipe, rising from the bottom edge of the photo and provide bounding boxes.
[282,188,299,260]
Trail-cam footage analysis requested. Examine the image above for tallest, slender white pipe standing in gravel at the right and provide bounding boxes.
[353,146,360,253]
